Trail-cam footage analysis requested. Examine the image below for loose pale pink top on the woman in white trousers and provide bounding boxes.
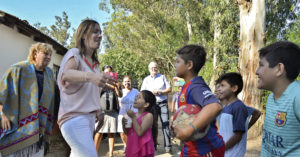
[57,48,101,126]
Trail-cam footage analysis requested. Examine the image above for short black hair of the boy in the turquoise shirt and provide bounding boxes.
[259,41,300,81]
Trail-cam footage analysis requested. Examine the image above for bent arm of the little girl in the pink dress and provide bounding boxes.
[127,110,153,136]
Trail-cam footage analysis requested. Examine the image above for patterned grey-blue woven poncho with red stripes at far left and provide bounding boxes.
[0,61,55,156]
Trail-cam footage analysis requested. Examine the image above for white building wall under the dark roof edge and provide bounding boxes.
[0,24,63,78]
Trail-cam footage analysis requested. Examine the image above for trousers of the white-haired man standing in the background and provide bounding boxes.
[153,101,171,149]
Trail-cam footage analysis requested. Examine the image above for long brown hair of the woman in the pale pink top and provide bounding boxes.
[75,19,99,62]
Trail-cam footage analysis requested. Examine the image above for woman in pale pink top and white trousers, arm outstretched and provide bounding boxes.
[57,19,115,157]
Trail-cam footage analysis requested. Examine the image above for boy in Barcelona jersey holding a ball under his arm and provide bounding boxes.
[173,45,225,157]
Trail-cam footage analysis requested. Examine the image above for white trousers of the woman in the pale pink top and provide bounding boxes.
[60,114,98,157]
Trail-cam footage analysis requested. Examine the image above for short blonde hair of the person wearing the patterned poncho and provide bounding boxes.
[27,42,53,63]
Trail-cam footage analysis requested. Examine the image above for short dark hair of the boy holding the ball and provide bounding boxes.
[176,45,206,74]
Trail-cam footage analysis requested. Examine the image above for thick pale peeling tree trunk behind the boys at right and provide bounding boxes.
[237,0,265,136]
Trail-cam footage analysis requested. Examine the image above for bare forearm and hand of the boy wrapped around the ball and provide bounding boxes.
[174,103,222,141]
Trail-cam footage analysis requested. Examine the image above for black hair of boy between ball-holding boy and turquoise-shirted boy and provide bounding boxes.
[216,72,244,95]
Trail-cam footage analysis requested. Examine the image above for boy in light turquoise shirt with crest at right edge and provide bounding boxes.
[256,41,300,157]
